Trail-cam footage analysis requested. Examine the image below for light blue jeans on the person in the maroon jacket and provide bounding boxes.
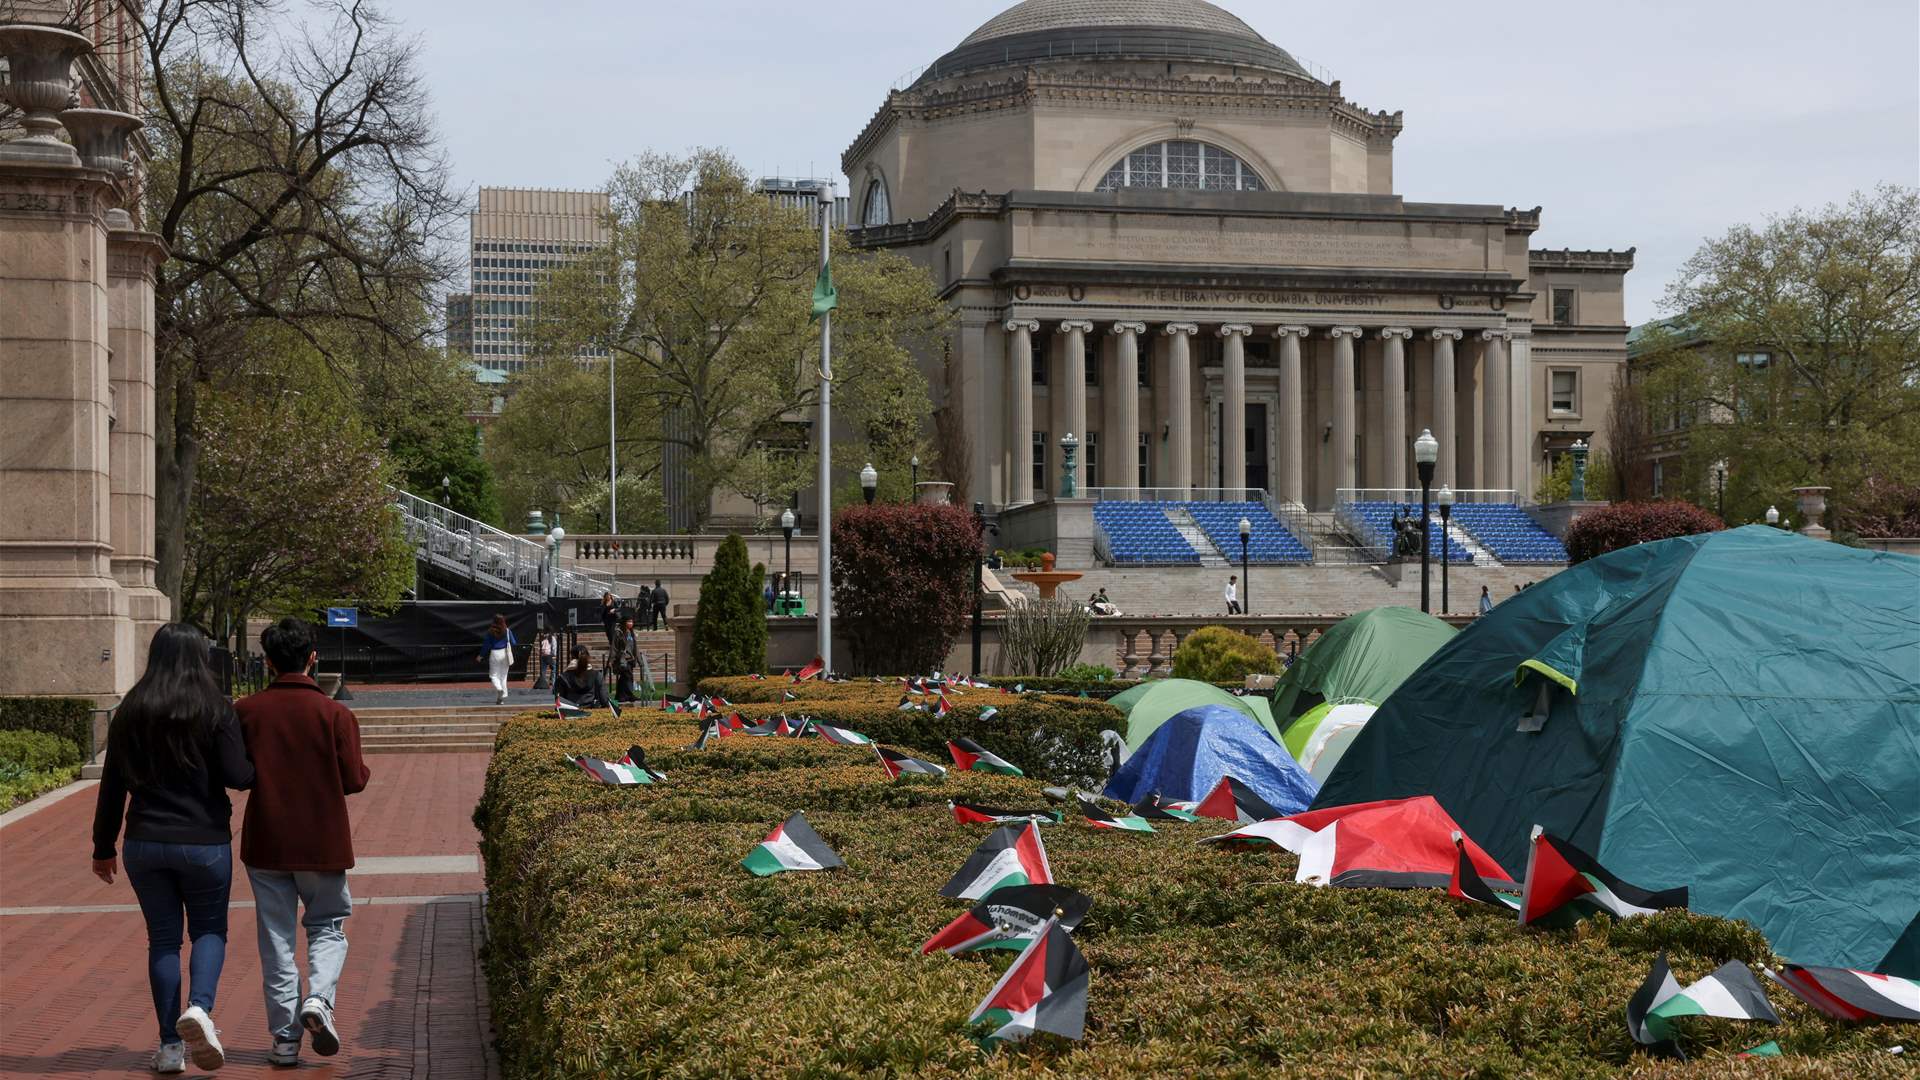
[246,867,353,1042]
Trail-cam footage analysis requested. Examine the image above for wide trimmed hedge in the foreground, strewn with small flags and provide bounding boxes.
[474,713,1910,1078]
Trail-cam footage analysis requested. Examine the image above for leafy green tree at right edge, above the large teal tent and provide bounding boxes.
[1644,186,1920,528]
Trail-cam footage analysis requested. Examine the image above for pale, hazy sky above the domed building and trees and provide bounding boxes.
[397,0,1920,323]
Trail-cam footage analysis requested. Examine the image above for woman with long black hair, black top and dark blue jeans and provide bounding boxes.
[94,623,253,1072]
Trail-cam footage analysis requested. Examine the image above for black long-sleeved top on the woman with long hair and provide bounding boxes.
[94,711,253,859]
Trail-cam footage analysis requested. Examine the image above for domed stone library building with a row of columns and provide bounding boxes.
[841,0,1632,522]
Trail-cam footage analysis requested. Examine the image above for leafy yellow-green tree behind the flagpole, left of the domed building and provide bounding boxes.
[522,150,950,525]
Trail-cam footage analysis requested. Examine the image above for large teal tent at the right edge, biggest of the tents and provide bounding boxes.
[1313,525,1920,976]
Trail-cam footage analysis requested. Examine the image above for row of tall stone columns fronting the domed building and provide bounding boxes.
[1004,317,1528,505]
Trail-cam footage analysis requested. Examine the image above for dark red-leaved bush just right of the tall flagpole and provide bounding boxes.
[833,505,981,675]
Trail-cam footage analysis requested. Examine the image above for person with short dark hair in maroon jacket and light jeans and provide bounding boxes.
[234,619,369,1067]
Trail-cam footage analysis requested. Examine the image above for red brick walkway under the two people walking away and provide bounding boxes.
[0,753,499,1080]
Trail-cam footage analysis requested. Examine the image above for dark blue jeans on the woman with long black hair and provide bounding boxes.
[121,840,234,1042]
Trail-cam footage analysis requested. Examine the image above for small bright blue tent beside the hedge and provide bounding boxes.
[1104,705,1319,813]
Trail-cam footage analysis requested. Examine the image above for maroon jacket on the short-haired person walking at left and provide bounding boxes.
[234,675,369,871]
